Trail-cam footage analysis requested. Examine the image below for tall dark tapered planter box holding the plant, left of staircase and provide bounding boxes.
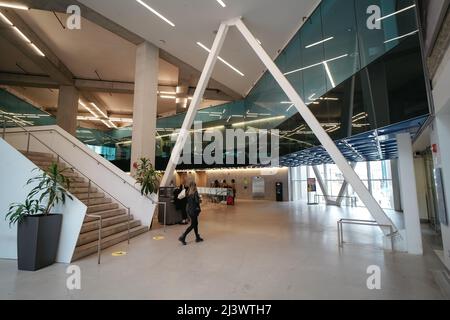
[17,214,62,271]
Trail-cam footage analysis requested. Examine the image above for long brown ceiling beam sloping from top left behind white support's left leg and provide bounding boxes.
[9,0,243,100]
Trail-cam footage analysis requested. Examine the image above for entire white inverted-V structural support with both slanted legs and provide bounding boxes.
[162,18,397,235]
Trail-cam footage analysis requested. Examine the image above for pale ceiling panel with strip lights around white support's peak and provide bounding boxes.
[80,0,319,95]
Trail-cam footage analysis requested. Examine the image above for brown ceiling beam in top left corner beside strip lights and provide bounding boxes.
[0,9,73,85]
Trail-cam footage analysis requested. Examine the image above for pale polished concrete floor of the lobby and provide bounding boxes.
[0,201,445,299]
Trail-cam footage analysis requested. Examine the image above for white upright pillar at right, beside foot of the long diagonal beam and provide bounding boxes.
[397,133,423,255]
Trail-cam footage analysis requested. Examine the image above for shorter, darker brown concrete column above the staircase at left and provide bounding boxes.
[56,86,80,136]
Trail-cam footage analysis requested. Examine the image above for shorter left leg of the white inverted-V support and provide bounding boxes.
[161,23,229,187]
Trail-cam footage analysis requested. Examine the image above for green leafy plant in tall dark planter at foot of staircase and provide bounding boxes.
[6,163,73,271]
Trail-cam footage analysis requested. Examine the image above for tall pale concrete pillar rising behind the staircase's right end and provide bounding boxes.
[131,42,159,171]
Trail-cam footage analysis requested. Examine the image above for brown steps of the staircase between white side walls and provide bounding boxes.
[22,151,148,261]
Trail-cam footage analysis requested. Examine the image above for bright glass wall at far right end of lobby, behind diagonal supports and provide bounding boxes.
[290,161,394,210]
